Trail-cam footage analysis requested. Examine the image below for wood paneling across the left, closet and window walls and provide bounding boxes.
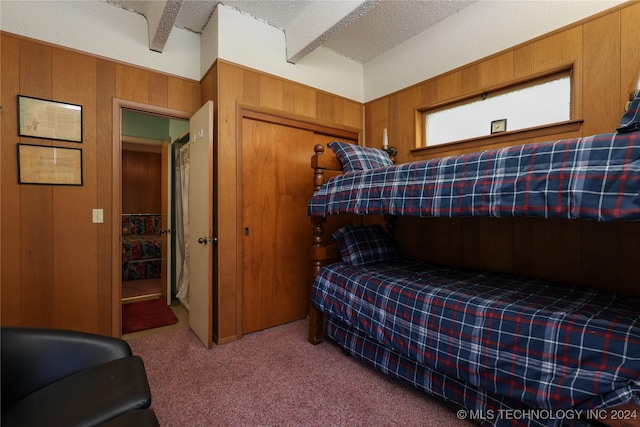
[0,4,640,343]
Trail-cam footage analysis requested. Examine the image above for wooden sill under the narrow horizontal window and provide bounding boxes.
[409,119,584,157]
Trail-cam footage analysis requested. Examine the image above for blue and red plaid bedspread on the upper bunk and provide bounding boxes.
[307,132,640,221]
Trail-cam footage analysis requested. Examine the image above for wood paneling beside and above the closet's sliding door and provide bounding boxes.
[201,60,363,343]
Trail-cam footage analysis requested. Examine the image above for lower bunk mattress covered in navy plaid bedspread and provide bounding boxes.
[311,258,640,426]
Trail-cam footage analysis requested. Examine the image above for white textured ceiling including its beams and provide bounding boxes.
[107,0,477,63]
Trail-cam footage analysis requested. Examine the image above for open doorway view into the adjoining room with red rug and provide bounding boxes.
[120,108,189,334]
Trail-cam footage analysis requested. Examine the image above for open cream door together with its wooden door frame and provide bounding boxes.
[111,98,217,348]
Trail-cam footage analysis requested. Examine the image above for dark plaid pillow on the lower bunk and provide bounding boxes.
[331,224,398,266]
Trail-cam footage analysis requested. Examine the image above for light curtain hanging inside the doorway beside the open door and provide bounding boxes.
[176,143,190,300]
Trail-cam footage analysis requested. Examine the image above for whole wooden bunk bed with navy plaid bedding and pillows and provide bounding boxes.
[308,88,640,426]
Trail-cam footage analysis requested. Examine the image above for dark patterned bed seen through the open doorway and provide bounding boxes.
[122,213,162,281]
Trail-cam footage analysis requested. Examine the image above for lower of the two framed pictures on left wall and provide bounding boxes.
[18,144,82,185]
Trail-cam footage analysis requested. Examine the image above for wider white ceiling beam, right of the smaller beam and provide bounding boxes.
[284,0,380,64]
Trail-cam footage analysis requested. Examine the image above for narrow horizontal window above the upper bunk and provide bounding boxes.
[423,70,571,147]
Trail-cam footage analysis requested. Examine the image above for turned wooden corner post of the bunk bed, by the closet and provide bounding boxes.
[308,144,327,345]
